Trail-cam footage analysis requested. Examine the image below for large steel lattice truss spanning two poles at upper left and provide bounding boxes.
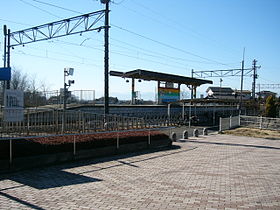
[8,10,105,47]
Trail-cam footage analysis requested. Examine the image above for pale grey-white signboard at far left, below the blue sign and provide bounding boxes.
[4,90,24,122]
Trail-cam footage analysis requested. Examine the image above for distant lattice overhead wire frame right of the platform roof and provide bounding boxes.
[192,68,253,78]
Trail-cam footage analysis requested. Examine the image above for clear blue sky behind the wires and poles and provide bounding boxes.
[0,0,280,100]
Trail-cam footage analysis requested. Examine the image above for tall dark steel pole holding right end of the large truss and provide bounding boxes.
[101,0,110,114]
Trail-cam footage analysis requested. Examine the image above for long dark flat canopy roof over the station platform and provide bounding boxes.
[110,69,213,86]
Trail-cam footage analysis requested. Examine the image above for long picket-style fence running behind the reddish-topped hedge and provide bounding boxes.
[0,109,174,139]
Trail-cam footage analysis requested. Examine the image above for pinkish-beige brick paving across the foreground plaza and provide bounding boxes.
[0,135,280,209]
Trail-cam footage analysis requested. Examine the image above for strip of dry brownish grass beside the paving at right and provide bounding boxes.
[223,128,280,140]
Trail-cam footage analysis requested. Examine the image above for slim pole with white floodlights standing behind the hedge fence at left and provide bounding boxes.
[62,68,75,132]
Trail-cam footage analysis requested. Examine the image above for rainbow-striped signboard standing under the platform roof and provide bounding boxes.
[158,87,180,103]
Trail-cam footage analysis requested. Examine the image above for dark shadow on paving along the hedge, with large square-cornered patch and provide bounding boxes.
[0,145,183,192]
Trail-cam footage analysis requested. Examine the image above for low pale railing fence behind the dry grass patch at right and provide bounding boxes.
[240,115,280,130]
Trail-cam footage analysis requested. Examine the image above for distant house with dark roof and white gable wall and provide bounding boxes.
[206,87,235,99]
